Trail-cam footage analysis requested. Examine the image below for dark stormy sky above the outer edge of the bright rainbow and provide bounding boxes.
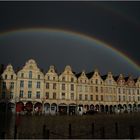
[0,1,140,75]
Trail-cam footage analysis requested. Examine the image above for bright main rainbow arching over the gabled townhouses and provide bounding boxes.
[0,27,140,70]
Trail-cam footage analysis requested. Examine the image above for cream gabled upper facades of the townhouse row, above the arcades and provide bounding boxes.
[0,59,140,114]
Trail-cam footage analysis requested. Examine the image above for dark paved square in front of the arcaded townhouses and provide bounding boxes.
[0,113,140,139]
